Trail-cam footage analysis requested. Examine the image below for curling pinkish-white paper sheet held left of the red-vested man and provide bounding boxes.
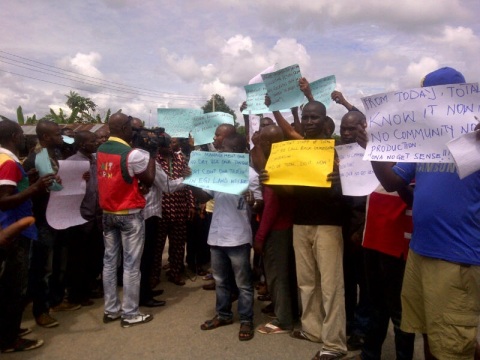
[46,160,90,230]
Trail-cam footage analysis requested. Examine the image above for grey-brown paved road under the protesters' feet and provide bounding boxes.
[14,270,423,360]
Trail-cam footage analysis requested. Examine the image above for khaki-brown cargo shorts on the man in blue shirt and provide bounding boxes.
[401,250,480,360]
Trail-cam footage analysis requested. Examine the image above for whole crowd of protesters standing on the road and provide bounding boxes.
[0,68,480,360]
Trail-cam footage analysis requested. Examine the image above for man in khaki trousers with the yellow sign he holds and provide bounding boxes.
[261,101,347,359]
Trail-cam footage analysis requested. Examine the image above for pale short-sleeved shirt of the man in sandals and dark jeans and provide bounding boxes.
[206,168,262,247]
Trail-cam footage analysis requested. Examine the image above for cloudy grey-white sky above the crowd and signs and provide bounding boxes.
[0,0,480,132]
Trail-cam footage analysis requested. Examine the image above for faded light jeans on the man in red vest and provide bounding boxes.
[103,212,145,318]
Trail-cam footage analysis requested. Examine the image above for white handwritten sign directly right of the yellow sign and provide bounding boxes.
[335,143,380,196]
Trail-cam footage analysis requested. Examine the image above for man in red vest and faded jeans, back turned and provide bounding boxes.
[97,113,156,327]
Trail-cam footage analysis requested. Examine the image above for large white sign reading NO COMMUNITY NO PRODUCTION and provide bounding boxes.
[362,84,480,163]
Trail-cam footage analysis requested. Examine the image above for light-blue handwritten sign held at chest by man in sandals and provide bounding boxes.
[183,151,249,195]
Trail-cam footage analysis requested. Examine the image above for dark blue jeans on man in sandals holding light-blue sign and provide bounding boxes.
[210,244,253,323]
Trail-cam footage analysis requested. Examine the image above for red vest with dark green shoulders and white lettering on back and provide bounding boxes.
[97,140,146,212]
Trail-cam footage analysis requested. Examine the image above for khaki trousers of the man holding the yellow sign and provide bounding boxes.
[293,225,347,353]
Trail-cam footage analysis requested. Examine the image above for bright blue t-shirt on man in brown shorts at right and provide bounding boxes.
[393,163,480,265]
